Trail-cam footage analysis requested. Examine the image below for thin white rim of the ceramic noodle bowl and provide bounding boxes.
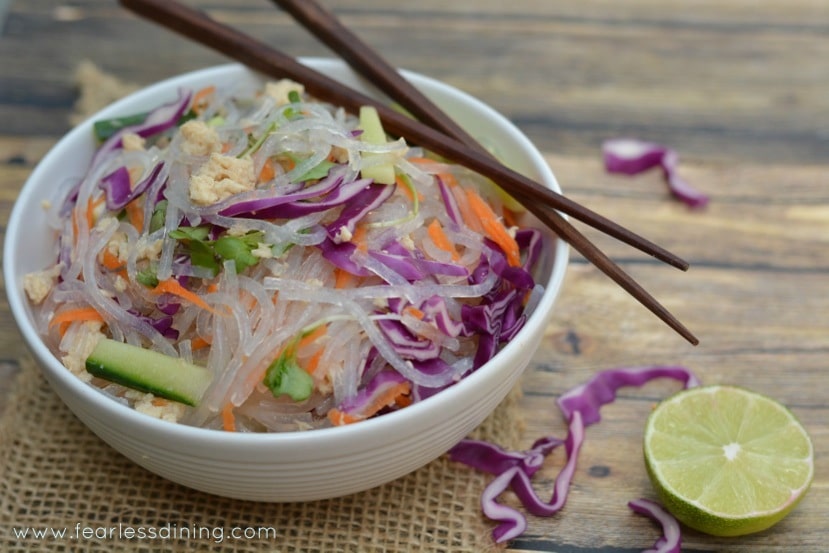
[3,57,569,448]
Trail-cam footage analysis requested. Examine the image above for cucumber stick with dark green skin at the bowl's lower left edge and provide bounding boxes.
[86,338,213,406]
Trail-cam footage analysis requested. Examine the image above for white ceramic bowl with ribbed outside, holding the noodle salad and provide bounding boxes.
[4,58,568,501]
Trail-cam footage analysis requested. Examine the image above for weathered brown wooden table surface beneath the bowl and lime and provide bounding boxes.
[0,0,829,552]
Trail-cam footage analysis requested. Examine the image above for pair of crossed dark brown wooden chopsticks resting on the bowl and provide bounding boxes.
[120,0,699,345]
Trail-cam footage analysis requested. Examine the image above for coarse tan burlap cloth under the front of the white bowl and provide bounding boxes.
[0,359,523,553]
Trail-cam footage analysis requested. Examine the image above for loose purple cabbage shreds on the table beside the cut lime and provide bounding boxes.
[449,366,699,552]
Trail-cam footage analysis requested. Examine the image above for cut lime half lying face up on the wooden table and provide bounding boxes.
[644,386,814,536]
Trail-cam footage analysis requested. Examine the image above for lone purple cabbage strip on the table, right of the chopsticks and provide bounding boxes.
[602,138,709,208]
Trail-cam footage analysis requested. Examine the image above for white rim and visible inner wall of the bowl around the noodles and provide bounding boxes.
[4,58,568,450]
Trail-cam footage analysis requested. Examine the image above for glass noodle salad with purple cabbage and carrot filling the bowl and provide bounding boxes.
[25,81,544,432]
